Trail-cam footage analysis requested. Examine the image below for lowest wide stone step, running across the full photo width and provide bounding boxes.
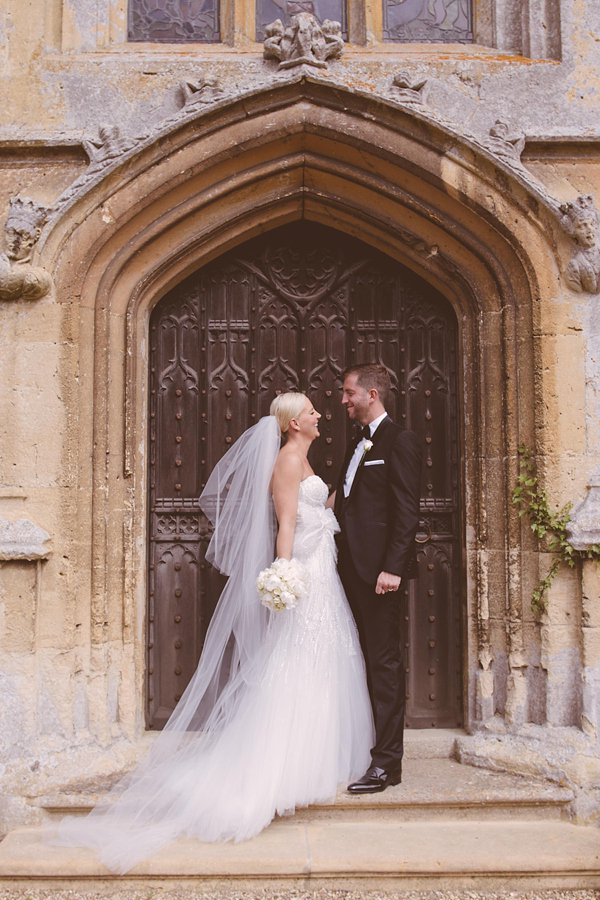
[0,817,600,896]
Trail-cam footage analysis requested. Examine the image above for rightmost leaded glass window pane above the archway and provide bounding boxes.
[383,0,473,44]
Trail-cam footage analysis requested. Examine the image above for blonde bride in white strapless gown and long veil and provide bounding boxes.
[51,393,373,873]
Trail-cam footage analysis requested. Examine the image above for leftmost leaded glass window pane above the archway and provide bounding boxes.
[128,0,220,44]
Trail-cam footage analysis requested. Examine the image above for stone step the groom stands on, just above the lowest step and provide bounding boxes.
[33,758,573,822]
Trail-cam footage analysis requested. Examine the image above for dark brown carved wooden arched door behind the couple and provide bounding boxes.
[147,221,462,728]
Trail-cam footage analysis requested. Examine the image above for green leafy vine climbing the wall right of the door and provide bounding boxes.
[512,444,600,612]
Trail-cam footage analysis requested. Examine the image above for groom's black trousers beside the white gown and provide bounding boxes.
[338,540,406,772]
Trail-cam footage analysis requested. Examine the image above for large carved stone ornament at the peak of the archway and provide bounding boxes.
[263,13,344,69]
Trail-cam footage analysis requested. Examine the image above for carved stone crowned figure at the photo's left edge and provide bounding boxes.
[0,197,52,300]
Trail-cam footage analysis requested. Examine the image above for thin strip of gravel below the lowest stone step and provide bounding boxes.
[0,888,600,900]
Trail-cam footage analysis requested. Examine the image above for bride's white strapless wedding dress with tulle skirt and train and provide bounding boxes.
[55,475,374,873]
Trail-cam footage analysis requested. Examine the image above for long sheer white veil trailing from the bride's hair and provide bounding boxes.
[49,416,280,873]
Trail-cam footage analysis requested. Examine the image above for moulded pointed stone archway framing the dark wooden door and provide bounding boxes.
[38,78,556,739]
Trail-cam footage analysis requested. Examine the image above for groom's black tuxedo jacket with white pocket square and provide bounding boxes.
[334,416,422,584]
